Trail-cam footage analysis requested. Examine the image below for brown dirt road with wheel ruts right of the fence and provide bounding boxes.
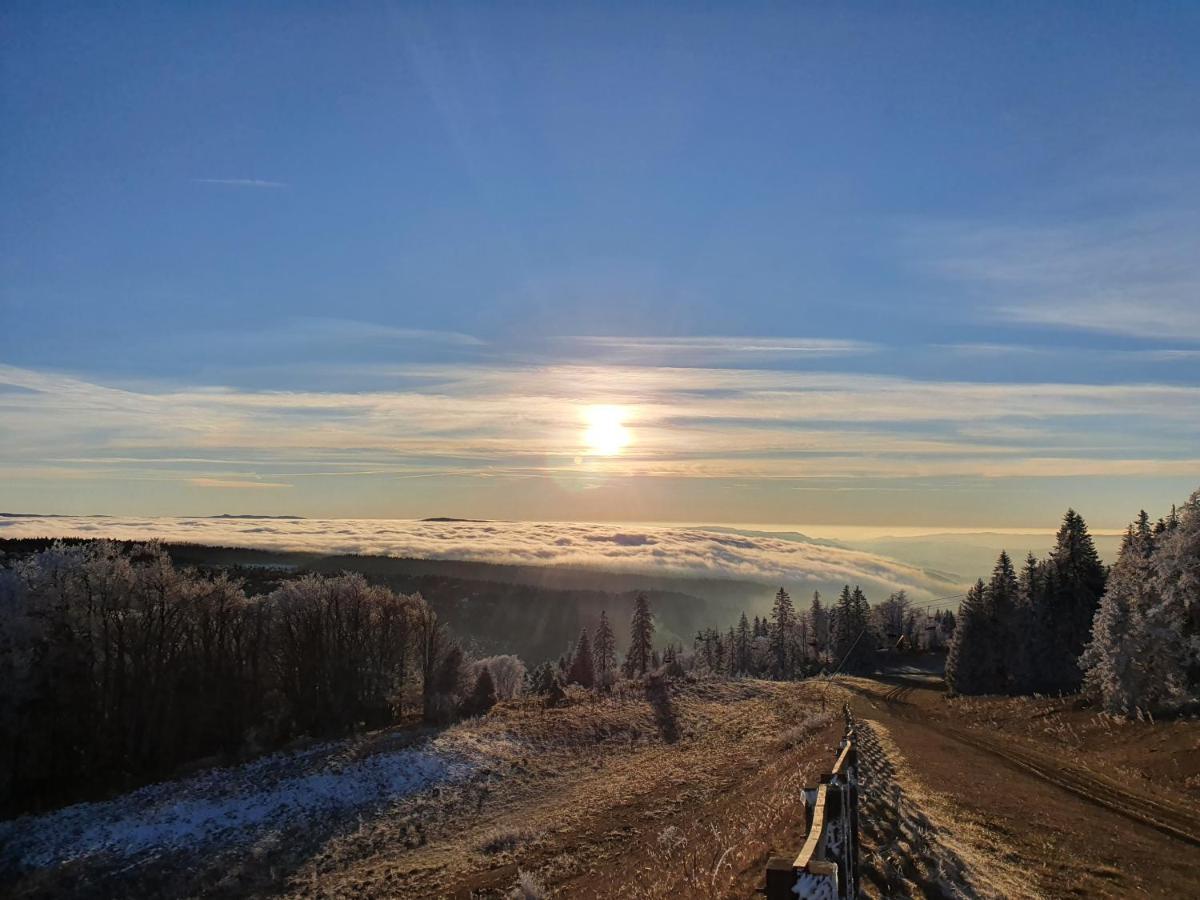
[814,677,1200,898]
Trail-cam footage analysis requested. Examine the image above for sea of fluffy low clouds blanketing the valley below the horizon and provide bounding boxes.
[0,516,958,599]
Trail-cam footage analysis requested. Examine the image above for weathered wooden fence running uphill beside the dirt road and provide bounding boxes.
[766,706,858,900]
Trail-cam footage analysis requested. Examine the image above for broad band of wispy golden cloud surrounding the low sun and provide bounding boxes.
[0,364,1200,487]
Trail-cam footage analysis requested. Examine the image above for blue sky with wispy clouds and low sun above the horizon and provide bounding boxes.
[0,2,1200,529]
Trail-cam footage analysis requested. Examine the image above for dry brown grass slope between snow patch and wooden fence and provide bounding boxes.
[283,679,841,900]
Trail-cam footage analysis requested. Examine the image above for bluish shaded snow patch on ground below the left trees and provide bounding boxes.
[0,736,504,870]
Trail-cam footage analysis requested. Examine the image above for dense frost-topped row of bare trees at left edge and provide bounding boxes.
[0,541,469,810]
